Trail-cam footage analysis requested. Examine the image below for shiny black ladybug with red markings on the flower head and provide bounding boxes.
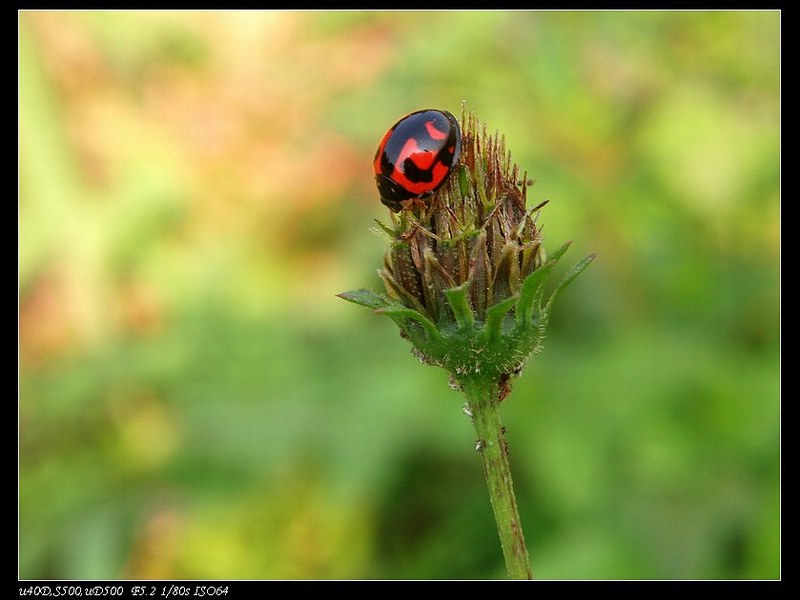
[373,110,461,212]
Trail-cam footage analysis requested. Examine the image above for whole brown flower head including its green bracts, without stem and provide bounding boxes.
[341,108,594,384]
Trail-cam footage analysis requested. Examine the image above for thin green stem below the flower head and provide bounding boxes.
[460,377,533,579]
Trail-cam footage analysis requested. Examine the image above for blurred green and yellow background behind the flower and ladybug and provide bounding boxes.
[19,11,781,579]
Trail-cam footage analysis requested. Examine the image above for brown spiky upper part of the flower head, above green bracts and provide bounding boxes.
[379,114,544,324]
